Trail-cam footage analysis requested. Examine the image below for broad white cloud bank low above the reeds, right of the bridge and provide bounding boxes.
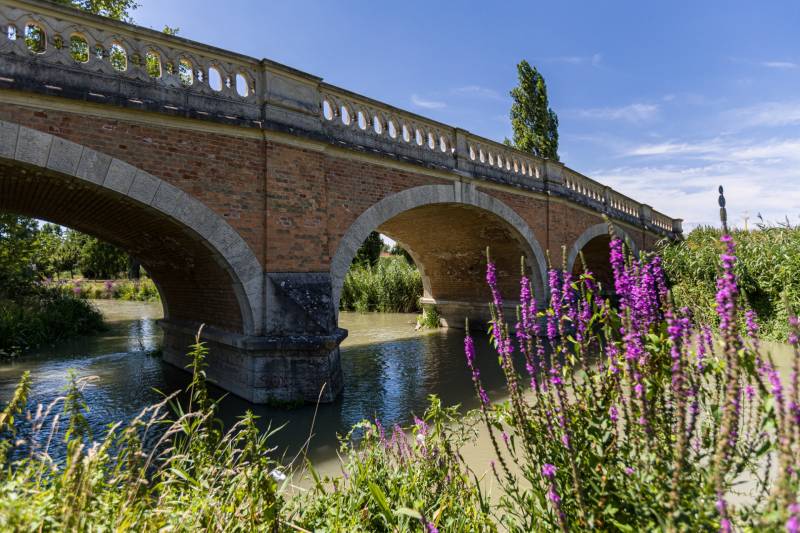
[589,137,800,229]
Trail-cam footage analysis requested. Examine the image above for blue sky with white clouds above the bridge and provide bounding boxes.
[134,0,800,227]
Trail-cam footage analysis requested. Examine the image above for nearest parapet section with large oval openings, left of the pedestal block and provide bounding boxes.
[0,0,262,125]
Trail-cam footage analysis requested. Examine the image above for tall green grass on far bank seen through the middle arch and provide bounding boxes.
[340,256,422,313]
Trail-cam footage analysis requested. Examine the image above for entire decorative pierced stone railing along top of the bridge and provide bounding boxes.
[0,0,681,236]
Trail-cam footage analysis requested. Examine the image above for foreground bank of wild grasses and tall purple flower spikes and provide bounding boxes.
[0,228,800,533]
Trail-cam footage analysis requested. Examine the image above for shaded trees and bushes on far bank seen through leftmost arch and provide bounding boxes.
[0,214,158,357]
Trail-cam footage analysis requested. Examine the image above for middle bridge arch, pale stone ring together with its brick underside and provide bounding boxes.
[331,183,547,327]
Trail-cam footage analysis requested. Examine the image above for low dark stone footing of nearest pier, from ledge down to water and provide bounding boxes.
[161,320,347,404]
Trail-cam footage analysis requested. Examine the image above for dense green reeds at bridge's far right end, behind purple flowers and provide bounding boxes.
[660,225,800,341]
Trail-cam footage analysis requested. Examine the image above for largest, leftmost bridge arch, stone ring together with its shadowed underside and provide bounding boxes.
[0,121,263,335]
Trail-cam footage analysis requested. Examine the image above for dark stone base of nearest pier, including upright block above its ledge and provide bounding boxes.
[161,273,347,404]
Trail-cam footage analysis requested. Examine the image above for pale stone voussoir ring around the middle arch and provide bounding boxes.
[331,182,547,313]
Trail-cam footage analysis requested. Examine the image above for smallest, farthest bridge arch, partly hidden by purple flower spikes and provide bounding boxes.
[567,222,639,291]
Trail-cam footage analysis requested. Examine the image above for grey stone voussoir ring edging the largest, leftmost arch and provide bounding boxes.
[0,121,263,335]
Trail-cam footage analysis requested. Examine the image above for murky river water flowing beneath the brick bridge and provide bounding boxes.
[0,300,510,464]
